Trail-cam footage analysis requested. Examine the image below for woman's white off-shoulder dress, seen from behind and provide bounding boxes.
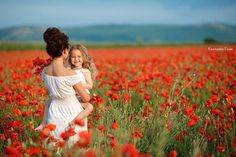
[42,69,87,143]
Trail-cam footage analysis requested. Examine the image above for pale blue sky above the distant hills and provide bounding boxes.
[0,0,236,28]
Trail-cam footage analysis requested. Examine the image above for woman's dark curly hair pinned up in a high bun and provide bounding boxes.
[43,27,69,58]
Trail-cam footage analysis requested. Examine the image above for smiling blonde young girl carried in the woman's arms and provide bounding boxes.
[35,44,97,131]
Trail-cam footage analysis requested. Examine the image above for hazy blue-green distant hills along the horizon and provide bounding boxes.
[0,23,236,43]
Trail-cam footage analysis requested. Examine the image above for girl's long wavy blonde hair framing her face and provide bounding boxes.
[69,44,98,81]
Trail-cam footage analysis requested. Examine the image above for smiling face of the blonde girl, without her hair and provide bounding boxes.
[70,49,84,68]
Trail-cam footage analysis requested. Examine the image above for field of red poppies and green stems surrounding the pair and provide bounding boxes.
[0,45,236,157]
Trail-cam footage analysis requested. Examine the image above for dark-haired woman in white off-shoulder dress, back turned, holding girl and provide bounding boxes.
[42,28,90,143]
